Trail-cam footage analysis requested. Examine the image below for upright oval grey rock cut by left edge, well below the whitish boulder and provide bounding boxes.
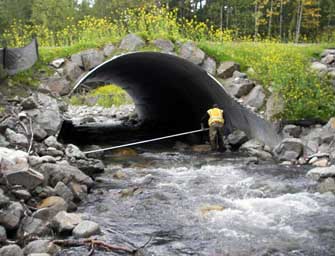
[0,202,23,230]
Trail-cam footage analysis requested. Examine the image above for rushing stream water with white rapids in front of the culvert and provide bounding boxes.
[62,151,335,256]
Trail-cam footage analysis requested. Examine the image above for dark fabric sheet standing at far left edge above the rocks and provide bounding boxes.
[0,39,38,75]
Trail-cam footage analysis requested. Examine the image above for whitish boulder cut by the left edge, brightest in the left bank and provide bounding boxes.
[0,148,29,173]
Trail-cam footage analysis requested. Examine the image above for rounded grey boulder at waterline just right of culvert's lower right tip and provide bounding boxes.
[273,138,304,161]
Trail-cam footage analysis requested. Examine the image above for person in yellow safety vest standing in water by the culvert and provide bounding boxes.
[201,104,224,150]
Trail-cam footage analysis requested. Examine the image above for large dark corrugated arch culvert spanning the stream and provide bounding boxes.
[59,52,279,146]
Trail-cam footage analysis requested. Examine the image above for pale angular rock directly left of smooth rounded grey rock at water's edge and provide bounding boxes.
[51,211,82,233]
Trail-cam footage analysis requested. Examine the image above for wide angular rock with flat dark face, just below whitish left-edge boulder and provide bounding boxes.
[5,169,44,190]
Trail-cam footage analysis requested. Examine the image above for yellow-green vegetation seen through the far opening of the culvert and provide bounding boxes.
[70,85,132,108]
